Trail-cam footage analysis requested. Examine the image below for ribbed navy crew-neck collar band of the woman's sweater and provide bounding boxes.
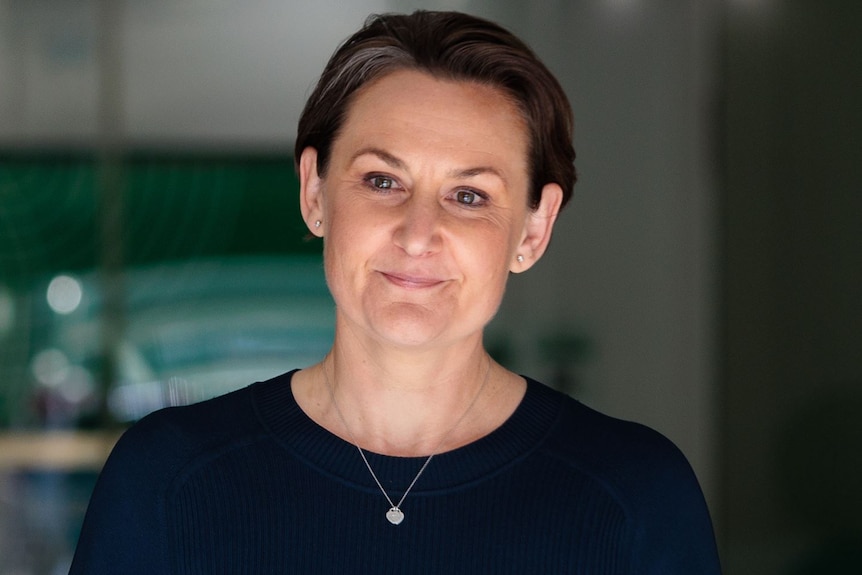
[252,370,565,495]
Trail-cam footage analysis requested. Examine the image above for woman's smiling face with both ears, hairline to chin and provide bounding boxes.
[300,70,559,354]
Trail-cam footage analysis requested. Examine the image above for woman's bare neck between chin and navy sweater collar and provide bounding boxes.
[291,322,526,457]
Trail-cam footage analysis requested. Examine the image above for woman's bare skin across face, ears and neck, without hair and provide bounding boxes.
[294,70,562,453]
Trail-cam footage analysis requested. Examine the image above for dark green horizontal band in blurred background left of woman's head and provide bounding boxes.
[0,154,321,285]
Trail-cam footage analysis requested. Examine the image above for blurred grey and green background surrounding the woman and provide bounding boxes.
[0,0,862,575]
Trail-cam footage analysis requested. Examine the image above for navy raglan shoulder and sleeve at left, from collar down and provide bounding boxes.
[70,376,294,575]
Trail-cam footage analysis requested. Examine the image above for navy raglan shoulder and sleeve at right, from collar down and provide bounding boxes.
[528,380,718,574]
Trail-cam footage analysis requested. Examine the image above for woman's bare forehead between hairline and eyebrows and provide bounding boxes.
[334,70,528,169]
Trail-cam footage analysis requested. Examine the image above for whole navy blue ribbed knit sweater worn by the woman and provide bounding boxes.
[71,373,719,575]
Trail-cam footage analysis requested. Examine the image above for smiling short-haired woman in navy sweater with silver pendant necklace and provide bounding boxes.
[72,12,718,575]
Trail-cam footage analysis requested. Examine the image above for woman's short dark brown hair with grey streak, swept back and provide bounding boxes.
[294,10,577,209]
